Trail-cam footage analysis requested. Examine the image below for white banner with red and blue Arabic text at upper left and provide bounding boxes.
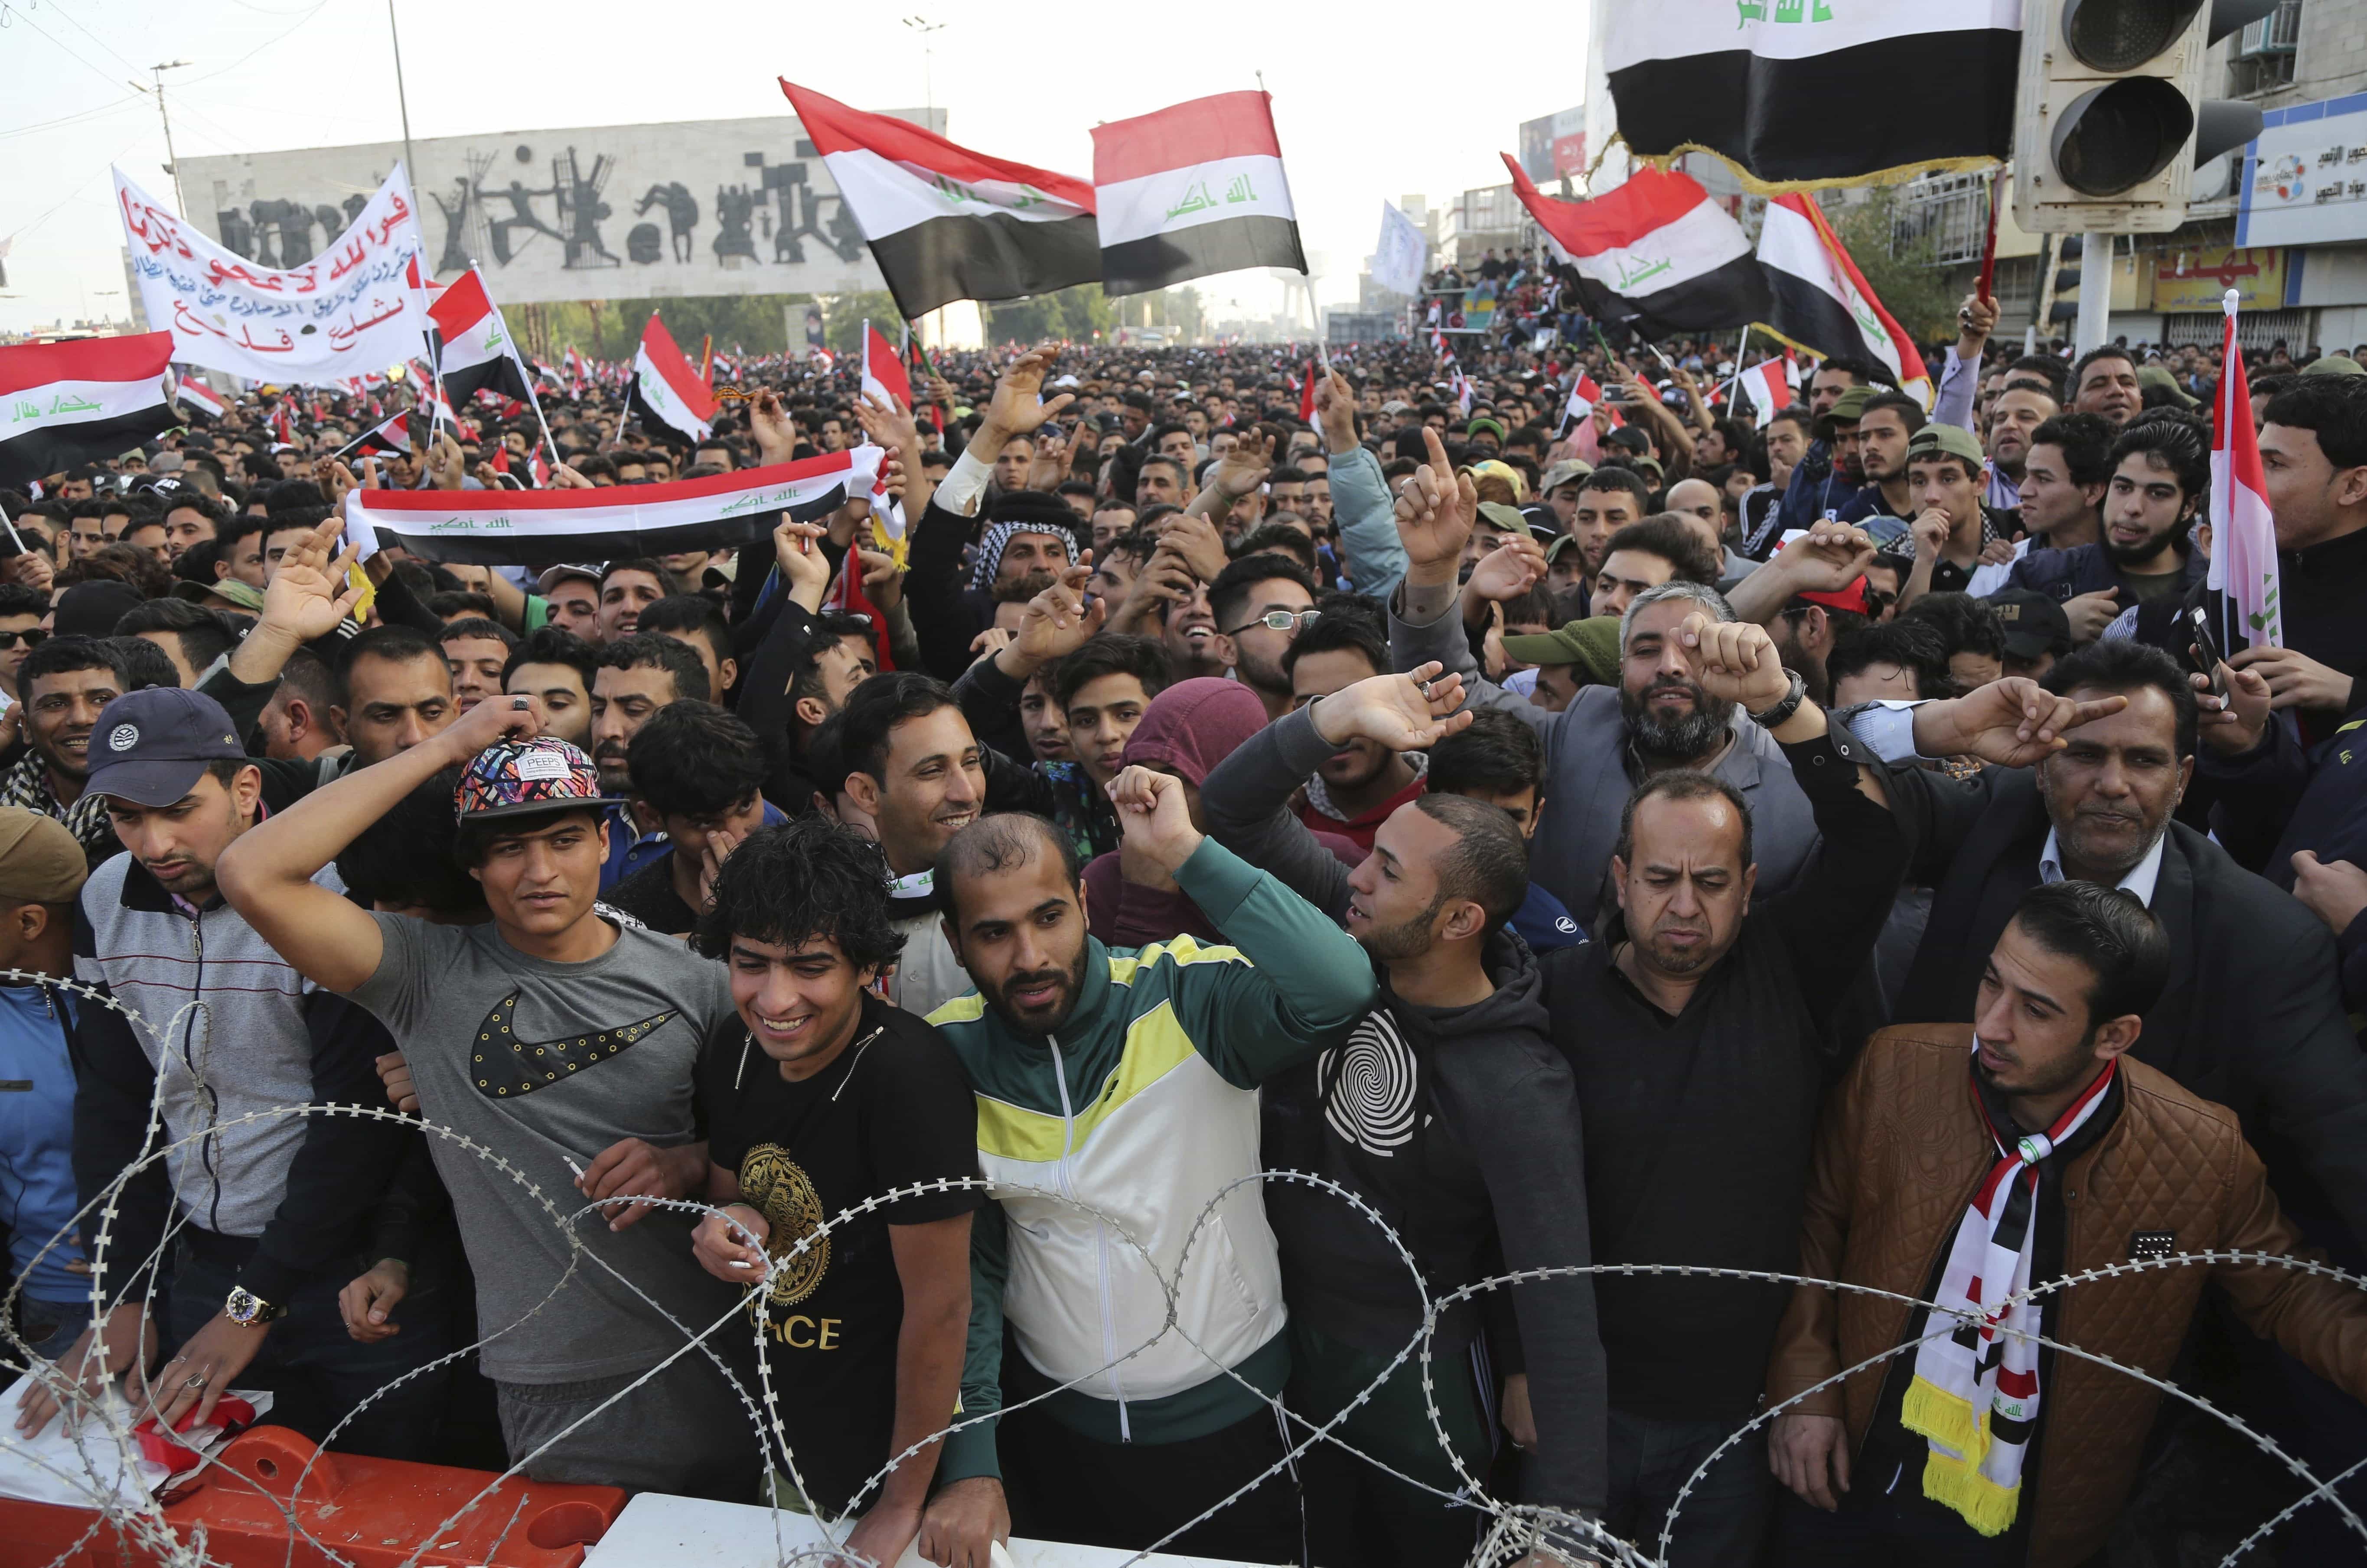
[116,163,428,385]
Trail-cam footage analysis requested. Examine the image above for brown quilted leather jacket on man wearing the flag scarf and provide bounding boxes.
[1768,1024,2367,1568]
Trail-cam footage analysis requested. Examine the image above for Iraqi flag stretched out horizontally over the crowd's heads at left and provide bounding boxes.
[346,447,885,565]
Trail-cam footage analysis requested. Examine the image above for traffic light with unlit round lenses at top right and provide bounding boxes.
[2014,0,2277,234]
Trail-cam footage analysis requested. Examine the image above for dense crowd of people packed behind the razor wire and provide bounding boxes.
[0,285,2367,1568]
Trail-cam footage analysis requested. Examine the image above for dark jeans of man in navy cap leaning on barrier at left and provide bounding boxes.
[163,1244,454,1459]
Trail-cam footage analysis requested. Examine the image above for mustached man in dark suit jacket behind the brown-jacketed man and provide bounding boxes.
[1853,638,2367,1267]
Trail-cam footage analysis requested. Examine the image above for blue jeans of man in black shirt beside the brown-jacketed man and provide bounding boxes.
[1602,1409,1775,1568]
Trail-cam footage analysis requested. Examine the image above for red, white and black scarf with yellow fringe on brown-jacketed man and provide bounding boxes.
[1901,1062,2121,1535]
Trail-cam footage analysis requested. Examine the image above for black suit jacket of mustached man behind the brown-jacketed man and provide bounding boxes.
[1891,769,2367,1242]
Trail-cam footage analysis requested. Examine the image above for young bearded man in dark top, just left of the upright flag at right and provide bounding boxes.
[2007,409,2211,646]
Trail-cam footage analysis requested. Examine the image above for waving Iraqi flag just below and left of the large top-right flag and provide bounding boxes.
[1503,156,1766,336]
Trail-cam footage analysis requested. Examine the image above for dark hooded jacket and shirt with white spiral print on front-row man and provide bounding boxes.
[1200,709,1607,1511]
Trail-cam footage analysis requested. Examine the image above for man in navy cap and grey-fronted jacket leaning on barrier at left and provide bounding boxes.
[16,686,450,1459]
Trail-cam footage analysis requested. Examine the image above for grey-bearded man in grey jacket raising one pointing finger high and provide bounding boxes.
[1389,440,1816,920]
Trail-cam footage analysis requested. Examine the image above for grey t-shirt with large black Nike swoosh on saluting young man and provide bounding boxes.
[350,915,739,1383]
